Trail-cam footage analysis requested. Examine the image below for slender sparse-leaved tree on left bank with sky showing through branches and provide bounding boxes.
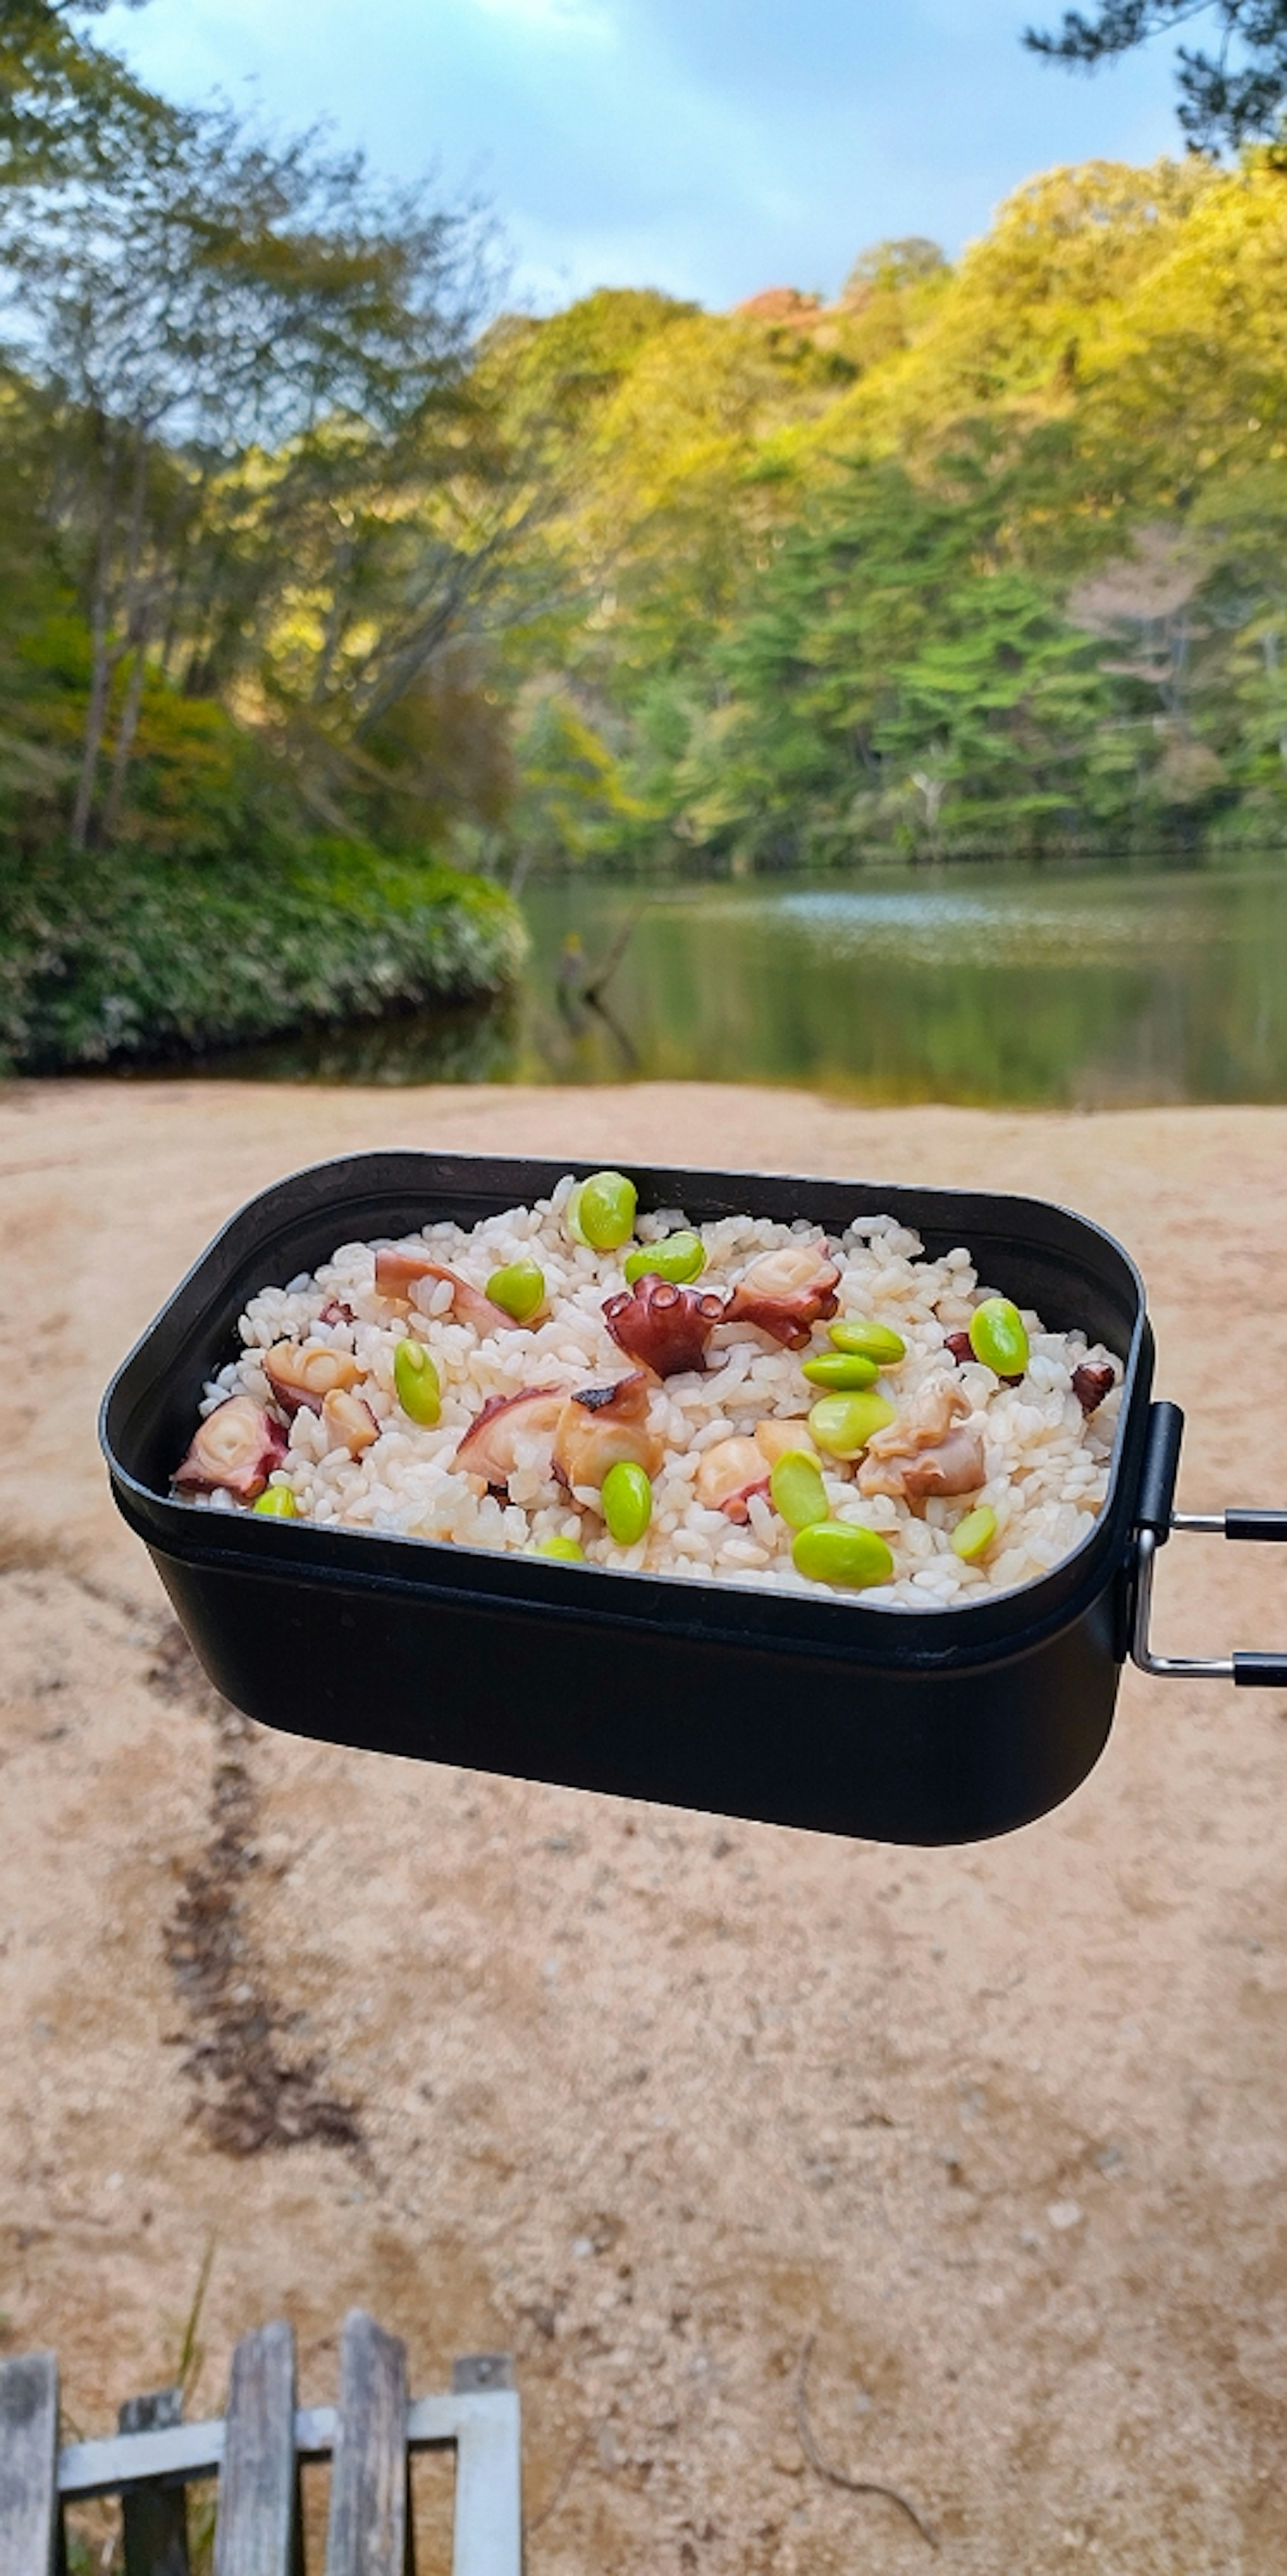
[0,28,497,847]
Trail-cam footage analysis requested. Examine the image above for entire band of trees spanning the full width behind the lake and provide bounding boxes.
[0,0,1287,881]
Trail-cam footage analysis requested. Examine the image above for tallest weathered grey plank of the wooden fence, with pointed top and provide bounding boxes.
[327,2308,412,2576]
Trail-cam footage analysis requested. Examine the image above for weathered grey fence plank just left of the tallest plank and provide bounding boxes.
[213,2321,301,2576]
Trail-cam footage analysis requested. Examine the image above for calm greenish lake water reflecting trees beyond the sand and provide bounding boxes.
[208,858,1287,1108]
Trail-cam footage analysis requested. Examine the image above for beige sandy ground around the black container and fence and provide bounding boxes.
[0,1082,1287,2576]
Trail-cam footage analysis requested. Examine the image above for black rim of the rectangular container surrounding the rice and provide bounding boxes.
[98,1149,1153,1672]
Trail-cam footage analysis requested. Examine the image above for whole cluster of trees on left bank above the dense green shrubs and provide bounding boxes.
[0,0,517,847]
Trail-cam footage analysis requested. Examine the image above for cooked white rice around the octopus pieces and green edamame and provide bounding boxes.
[186,1177,1122,1610]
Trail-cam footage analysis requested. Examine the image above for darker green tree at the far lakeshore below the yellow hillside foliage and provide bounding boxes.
[654,458,1114,860]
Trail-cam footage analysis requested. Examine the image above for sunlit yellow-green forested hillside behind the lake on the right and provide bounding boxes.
[489,154,1287,866]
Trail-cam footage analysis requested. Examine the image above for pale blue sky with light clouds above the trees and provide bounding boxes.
[108,0,1176,309]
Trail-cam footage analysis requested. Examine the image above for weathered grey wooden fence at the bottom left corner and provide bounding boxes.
[0,2308,523,2576]
